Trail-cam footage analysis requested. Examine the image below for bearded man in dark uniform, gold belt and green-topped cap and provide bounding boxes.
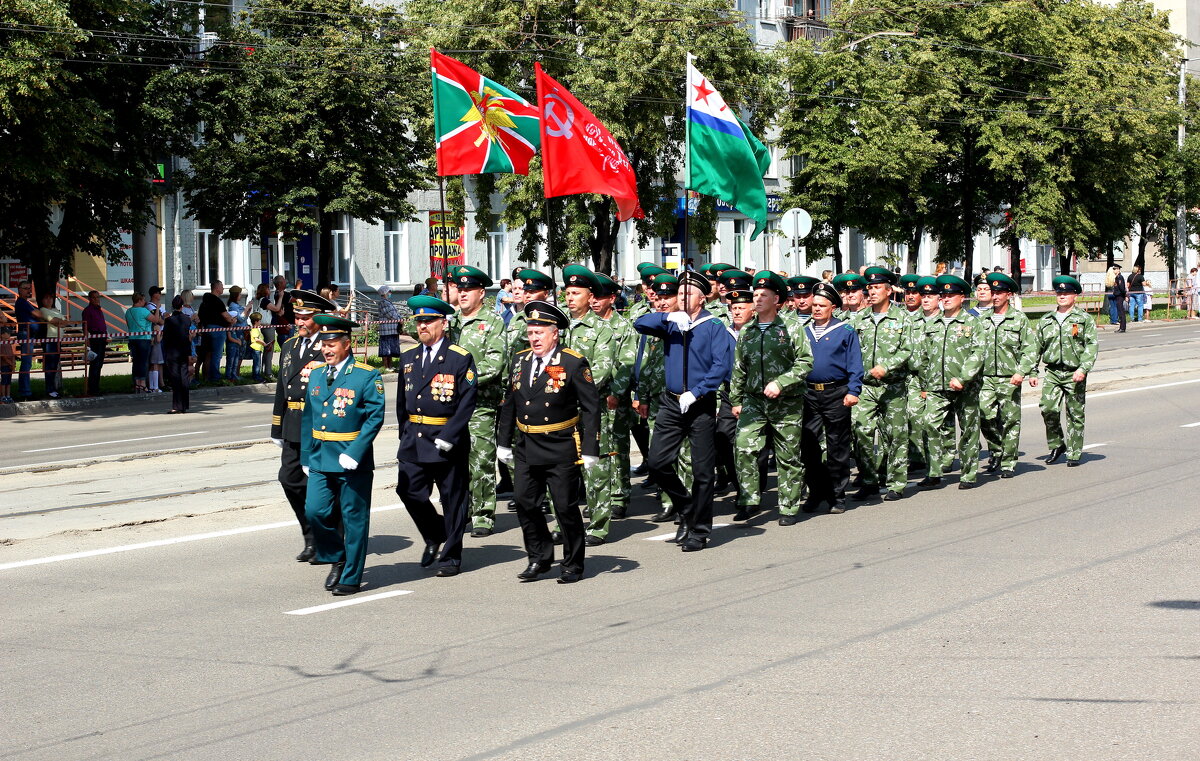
[396,296,478,576]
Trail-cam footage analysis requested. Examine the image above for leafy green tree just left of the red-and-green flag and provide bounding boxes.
[157,0,432,281]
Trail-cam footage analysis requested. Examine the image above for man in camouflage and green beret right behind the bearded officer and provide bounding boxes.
[449,265,508,537]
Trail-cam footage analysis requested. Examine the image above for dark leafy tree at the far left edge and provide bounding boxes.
[0,0,188,292]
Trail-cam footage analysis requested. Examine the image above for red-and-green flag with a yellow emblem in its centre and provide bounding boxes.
[430,48,540,176]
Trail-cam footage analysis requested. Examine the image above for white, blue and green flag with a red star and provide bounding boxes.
[686,55,770,240]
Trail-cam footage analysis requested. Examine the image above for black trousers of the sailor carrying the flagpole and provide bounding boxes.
[647,391,716,539]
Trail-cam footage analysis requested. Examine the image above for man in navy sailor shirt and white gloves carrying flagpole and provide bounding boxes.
[634,271,734,552]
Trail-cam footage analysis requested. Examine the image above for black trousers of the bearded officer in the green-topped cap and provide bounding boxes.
[396,459,470,565]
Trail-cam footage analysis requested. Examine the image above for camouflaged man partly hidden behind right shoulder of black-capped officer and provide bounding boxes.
[562,264,617,547]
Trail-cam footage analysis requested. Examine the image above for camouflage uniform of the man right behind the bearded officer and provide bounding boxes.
[449,306,506,531]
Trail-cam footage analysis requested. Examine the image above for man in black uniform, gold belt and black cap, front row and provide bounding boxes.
[496,301,600,583]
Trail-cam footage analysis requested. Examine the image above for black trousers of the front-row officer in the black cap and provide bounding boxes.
[514,453,583,574]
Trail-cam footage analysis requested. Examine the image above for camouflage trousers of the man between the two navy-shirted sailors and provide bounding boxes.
[733,399,804,515]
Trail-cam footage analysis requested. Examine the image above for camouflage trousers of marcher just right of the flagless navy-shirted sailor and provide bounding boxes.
[851,381,908,492]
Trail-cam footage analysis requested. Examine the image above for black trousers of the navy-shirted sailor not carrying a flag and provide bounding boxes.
[800,384,852,505]
